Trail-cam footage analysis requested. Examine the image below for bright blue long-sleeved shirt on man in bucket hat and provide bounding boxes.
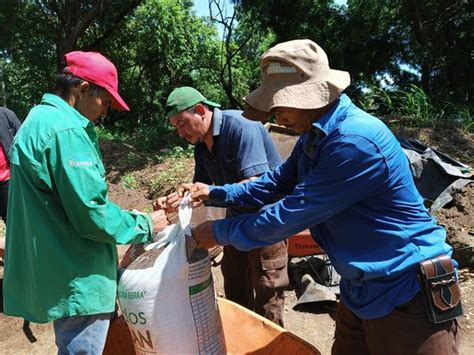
[208,95,452,319]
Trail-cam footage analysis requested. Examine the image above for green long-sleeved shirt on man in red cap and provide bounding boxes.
[4,94,153,323]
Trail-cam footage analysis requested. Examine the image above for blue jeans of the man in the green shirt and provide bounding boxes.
[54,313,112,355]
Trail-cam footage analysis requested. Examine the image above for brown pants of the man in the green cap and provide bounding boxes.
[221,241,289,326]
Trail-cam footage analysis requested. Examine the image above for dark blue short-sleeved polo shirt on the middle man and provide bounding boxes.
[193,108,282,215]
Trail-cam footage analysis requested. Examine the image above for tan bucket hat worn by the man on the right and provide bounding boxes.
[243,39,351,120]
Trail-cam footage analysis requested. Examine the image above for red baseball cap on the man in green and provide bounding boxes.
[64,51,130,111]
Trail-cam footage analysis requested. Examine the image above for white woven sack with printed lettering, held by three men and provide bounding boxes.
[118,199,226,354]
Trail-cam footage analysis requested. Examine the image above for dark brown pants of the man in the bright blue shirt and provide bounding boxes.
[332,293,459,355]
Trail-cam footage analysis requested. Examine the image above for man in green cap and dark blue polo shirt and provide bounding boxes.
[159,87,288,325]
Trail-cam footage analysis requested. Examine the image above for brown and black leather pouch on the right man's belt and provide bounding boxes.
[418,254,463,323]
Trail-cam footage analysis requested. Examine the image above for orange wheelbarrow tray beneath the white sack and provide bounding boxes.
[104,297,320,355]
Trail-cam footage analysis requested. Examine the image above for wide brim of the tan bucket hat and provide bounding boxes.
[244,69,351,117]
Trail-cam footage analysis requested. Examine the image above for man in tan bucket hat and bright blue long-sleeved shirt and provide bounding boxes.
[183,40,457,354]
